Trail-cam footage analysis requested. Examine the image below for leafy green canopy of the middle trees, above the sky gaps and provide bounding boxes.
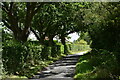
[31,2,85,45]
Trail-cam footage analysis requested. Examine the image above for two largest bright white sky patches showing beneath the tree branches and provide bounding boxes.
[29,33,79,42]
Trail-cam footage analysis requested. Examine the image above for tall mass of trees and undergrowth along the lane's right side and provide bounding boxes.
[75,2,120,80]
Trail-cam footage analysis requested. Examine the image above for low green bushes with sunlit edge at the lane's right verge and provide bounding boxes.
[74,50,120,80]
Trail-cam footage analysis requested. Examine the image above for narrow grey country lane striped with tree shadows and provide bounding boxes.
[32,51,87,80]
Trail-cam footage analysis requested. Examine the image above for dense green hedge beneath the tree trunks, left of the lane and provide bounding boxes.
[2,41,63,77]
